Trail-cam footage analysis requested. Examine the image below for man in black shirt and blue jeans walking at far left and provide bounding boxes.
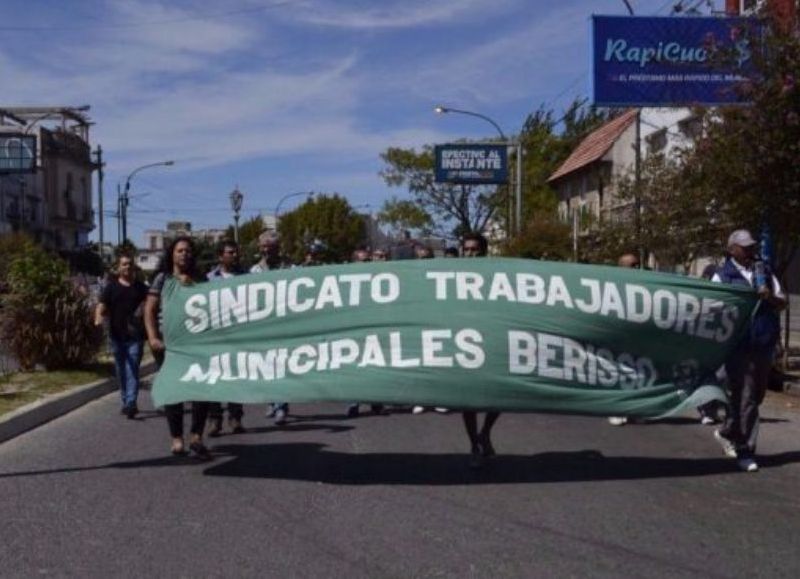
[95,254,147,418]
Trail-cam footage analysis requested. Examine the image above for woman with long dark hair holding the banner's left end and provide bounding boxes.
[144,236,210,459]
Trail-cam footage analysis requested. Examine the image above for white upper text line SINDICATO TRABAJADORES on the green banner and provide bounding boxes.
[183,271,739,343]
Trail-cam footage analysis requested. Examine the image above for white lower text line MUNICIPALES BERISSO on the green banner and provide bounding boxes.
[181,328,658,390]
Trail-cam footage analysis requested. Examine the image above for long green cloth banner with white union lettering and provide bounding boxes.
[153,258,757,416]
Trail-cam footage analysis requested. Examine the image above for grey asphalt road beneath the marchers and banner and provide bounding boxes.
[0,380,800,578]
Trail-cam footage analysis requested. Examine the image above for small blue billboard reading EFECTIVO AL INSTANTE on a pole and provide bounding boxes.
[434,145,508,185]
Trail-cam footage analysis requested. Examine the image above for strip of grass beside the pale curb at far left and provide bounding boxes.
[0,361,114,415]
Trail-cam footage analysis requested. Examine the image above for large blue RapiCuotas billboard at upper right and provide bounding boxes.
[592,16,760,107]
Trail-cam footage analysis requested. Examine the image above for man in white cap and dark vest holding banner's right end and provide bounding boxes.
[711,229,786,472]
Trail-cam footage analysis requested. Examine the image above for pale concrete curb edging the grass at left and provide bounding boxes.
[0,362,156,443]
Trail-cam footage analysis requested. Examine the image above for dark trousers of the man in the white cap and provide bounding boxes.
[720,348,773,458]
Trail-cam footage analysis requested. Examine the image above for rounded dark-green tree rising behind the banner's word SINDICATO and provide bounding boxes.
[278,194,366,263]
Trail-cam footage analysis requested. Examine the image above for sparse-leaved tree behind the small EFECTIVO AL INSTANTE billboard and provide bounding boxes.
[380,145,507,237]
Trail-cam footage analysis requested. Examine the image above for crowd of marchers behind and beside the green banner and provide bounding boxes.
[95,229,786,472]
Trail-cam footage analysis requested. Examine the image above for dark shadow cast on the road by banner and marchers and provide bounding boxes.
[7,443,800,485]
